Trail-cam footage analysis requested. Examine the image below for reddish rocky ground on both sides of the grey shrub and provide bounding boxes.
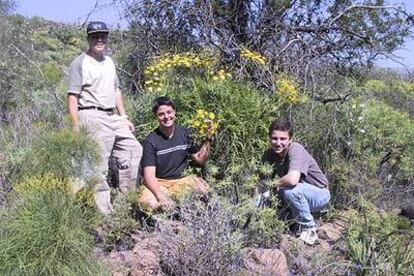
[95,217,345,276]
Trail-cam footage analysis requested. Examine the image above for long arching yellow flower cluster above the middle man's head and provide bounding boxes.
[144,53,212,92]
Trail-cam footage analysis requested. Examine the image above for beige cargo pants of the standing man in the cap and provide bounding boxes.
[78,109,142,215]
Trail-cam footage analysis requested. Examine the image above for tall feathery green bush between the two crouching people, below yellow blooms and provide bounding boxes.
[134,73,282,202]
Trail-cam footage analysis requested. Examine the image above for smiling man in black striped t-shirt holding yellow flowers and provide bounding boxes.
[139,97,210,211]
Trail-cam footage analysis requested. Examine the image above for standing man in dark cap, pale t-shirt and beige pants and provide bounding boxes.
[68,22,142,215]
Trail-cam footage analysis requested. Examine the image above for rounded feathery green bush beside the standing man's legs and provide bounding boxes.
[16,129,98,181]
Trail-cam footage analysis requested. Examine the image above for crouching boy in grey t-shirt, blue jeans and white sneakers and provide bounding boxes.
[262,119,331,245]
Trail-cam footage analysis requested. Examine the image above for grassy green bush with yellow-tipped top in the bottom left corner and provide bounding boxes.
[0,181,103,275]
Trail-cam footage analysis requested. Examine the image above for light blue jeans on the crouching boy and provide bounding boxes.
[279,182,331,227]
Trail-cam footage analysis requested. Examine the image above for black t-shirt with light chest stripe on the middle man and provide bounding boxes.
[141,125,198,179]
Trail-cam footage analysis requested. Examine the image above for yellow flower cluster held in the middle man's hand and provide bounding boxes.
[190,109,218,138]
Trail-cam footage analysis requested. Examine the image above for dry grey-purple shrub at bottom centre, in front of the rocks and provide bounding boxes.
[157,194,243,275]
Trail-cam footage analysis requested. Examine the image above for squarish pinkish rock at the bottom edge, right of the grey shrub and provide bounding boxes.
[244,248,289,276]
